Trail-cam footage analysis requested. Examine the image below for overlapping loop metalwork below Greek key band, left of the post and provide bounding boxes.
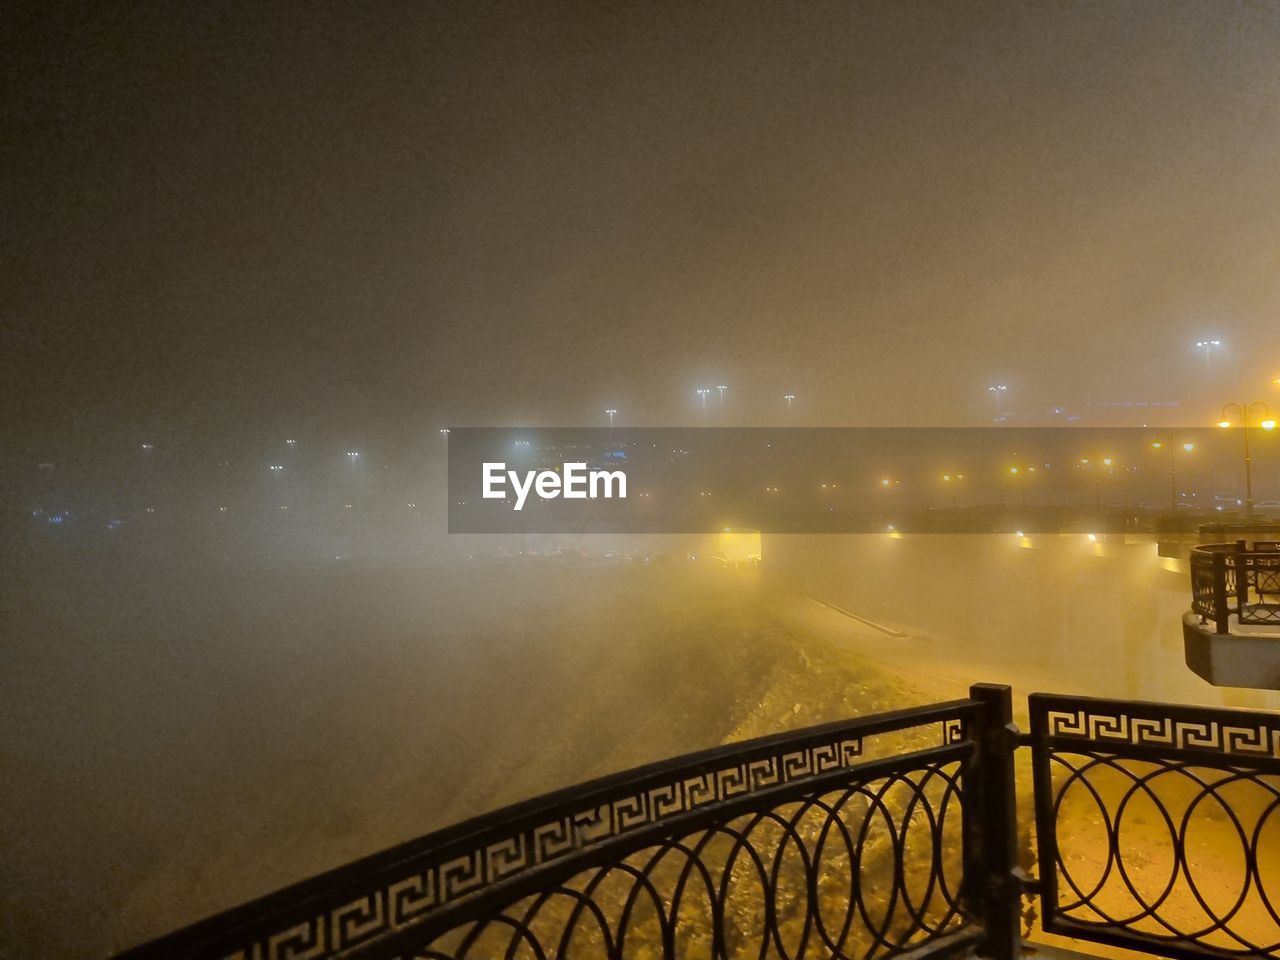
[408,762,969,960]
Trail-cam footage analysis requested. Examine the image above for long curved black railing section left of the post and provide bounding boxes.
[122,689,1007,960]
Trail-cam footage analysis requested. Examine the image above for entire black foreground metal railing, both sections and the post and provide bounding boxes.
[122,684,1280,960]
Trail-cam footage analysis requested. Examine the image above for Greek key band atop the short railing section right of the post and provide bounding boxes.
[1047,708,1280,758]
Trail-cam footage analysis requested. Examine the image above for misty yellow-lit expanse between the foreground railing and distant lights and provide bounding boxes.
[0,536,1280,957]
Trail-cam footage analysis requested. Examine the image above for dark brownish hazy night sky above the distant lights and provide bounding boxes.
[0,0,1280,444]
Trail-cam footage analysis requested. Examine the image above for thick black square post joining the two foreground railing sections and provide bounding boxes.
[965,684,1023,960]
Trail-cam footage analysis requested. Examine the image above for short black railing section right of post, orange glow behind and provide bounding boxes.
[1030,694,1280,957]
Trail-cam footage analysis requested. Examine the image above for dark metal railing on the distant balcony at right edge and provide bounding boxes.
[1190,540,1280,634]
